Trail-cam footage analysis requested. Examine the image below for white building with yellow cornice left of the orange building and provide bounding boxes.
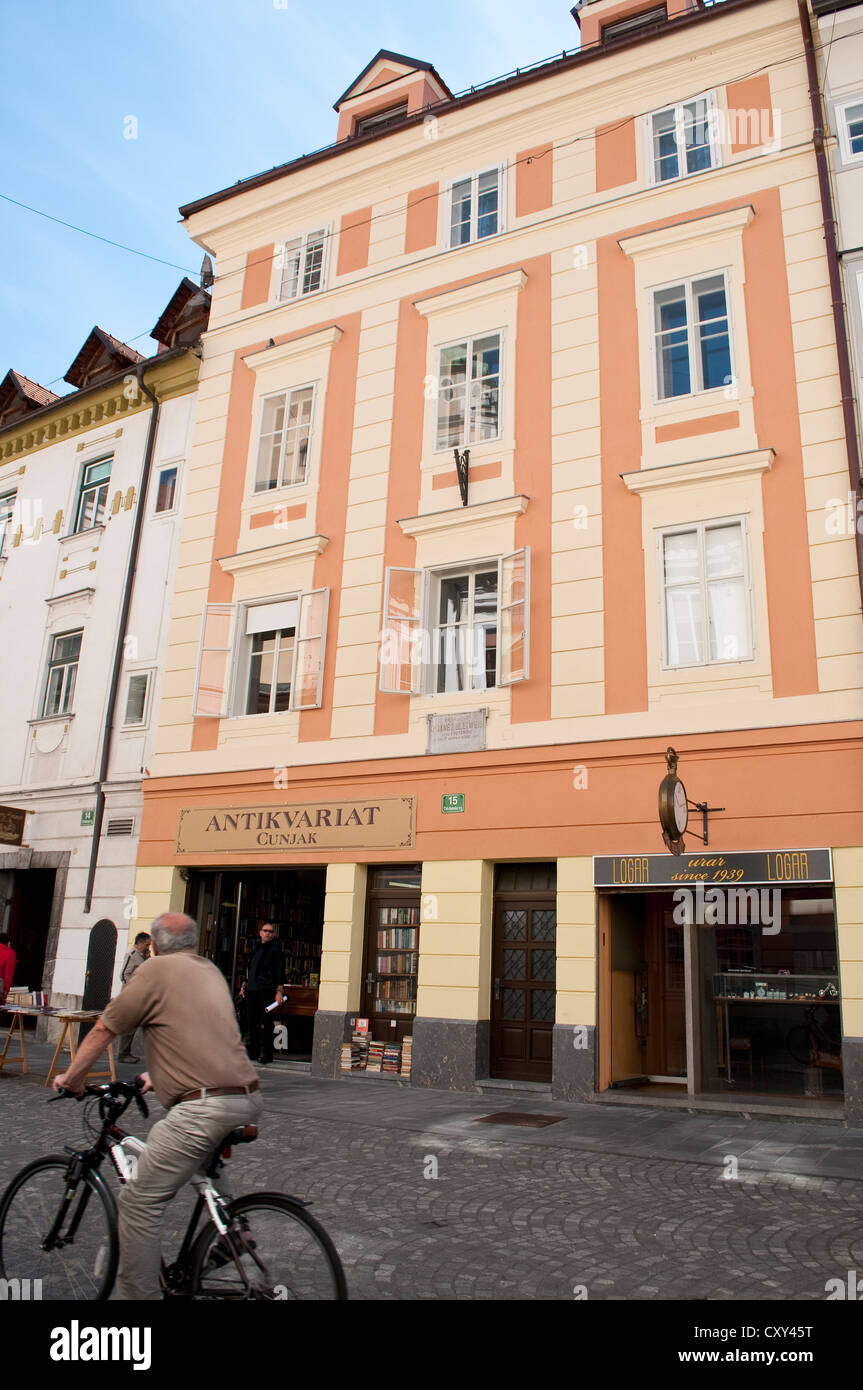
[0,281,208,1006]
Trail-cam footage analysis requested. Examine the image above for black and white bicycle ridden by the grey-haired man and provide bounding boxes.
[0,1077,347,1302]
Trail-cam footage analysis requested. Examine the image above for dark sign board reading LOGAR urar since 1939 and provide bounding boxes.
[593,849,832,888]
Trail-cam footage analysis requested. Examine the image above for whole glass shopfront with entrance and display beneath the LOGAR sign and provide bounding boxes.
[599,883,844,1108]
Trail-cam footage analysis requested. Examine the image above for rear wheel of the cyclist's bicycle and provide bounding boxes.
[189,1193,347,1302]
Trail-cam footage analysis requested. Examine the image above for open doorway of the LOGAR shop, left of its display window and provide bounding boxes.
[609,894,687,1087]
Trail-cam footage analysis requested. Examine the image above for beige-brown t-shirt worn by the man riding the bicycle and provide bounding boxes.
[101,951,257,1106]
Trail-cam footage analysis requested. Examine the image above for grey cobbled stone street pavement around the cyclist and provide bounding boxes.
[0,1047,863,1301]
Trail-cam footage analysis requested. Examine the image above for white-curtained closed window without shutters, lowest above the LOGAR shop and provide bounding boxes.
[657,517,755,669]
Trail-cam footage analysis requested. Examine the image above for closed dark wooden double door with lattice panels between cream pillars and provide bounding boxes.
[489,892,557,1081]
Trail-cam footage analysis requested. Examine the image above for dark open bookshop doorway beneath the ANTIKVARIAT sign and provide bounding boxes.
[186,867,327,1061]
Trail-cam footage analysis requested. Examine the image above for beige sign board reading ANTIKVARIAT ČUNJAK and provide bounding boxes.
[176,796,417,856]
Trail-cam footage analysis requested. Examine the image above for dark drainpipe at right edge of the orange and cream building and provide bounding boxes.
[798,0,863,602]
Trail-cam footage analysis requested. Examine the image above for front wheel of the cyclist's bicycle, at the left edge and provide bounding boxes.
[0,1154,120,1301]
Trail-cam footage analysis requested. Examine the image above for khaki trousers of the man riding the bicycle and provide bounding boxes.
[117,1091,264,1301]
